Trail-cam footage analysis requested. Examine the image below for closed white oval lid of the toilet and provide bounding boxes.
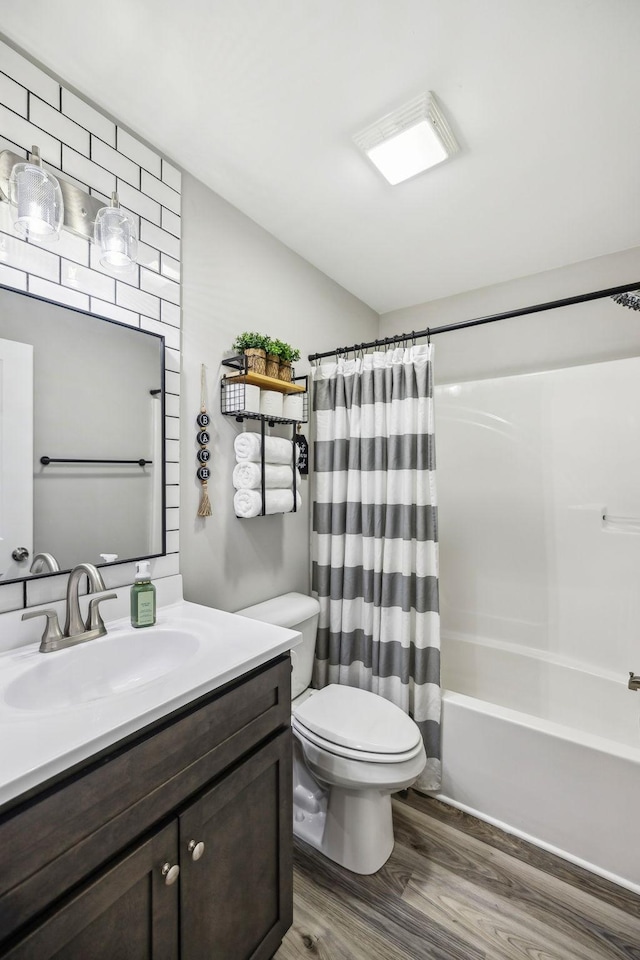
[294,684,421,755]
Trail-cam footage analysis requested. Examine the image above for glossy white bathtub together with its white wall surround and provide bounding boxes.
[435,356,640,892]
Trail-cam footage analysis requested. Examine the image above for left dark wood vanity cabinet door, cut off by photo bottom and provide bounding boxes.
[1,820,180,960]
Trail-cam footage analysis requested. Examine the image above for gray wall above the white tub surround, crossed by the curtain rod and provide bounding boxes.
[380,247,640,383]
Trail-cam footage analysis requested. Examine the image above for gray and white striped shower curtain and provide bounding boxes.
[312,344,440,790]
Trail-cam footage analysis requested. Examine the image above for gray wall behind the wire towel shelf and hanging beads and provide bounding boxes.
[180,175,378,610]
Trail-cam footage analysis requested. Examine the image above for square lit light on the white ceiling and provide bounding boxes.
[353,93,460,185]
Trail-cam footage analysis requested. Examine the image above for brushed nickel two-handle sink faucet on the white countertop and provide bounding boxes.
[22,563,117,653]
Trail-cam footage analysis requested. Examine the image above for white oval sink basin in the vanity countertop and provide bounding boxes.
[4,627,200,711]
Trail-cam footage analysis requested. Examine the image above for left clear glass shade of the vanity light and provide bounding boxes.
[9,163,64,241]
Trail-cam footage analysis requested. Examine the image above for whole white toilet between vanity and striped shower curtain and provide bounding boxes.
[237,593,426,874]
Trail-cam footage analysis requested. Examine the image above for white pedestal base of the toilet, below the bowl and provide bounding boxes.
[293,738,394,875]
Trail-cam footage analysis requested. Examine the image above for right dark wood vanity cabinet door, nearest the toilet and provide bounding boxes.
[180,730,293,960]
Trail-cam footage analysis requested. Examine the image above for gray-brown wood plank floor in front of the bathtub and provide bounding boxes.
[274,791,640,960]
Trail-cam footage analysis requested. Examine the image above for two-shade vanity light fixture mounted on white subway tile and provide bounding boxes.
[0,147,138,270]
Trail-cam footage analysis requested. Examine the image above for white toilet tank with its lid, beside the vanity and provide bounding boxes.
[236,593,320,700]
